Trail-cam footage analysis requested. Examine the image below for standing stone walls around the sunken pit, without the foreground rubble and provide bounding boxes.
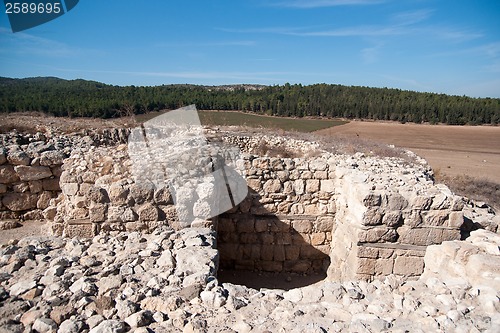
[29,128,464,281]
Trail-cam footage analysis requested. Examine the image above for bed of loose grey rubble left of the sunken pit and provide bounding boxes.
[0,228,219,333]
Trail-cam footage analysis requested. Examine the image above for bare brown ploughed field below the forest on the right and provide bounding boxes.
[316,121,500,183]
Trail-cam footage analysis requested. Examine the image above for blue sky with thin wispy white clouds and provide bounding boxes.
[0,0,500,97]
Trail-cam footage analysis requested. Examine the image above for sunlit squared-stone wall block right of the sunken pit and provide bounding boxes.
[330,156,464,280]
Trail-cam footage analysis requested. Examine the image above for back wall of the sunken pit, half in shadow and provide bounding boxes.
[218,156,336,273]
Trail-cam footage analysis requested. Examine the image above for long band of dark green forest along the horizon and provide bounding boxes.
[0,77,500,124]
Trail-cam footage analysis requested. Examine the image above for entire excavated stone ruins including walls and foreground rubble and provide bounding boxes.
[0,110,500,333]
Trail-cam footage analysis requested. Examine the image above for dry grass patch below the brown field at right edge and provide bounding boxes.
[434,169,500,211]
